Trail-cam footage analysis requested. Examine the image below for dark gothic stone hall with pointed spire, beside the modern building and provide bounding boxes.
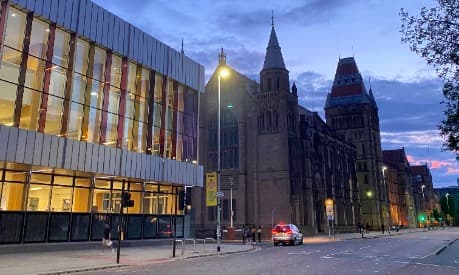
[195,22,361,237]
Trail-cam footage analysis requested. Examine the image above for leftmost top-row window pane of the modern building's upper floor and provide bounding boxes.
[4,7,26,51]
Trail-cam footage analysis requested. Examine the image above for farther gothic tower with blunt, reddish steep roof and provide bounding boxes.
[325,57,389,230]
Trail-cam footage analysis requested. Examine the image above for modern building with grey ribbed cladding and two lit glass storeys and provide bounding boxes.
[0,0,204,244]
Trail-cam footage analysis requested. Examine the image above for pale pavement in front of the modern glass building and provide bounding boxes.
[0,242,254,275]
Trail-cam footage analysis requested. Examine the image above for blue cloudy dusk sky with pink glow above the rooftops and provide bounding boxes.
[93,0,459,187]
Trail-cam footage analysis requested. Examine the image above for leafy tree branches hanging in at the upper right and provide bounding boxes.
[400,0,459,160]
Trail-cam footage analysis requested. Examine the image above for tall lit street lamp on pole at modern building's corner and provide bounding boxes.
[217,67,229,252]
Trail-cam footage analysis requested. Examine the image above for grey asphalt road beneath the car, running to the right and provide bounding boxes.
[83,229,459,275]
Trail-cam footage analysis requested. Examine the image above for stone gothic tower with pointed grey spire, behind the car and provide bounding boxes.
[249,22,303,229]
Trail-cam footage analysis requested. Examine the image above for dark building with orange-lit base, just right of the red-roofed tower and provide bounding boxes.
[383,148,417,227]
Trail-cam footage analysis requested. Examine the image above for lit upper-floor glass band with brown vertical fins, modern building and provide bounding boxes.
[0,7,198,161]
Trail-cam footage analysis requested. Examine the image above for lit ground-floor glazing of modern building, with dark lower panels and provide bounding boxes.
[0,170,184,243]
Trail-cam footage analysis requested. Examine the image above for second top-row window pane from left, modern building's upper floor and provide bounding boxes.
[29,18,50,60]
